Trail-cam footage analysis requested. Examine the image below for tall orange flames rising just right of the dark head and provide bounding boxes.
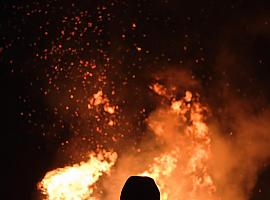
[142,87,216,200]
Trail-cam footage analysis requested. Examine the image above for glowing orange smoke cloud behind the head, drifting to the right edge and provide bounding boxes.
[100,66,270,200]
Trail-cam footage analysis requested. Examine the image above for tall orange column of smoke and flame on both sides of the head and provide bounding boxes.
[97,70,215,200]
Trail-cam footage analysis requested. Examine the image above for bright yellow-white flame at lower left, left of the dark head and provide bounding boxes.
[38,151,117,200]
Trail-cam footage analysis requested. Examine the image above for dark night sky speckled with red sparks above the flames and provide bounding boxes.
[0,0,270,200]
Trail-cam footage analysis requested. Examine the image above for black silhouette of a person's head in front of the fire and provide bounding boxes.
[120,176,160,200]
